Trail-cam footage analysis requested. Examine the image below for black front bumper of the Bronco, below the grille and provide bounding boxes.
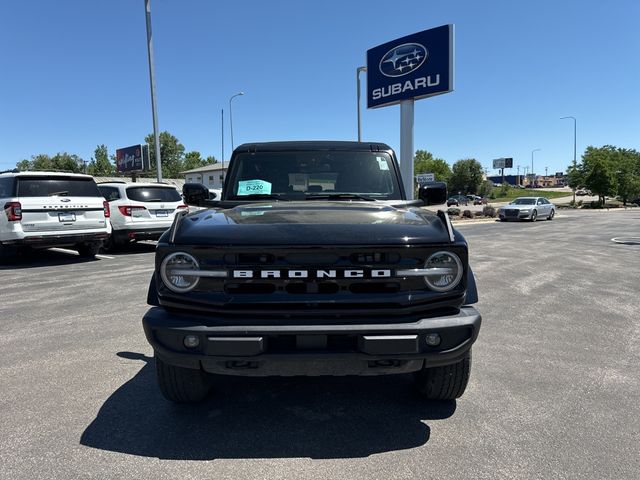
[142,307,482,376]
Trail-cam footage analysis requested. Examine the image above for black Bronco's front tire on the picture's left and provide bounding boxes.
[155,355,211,403]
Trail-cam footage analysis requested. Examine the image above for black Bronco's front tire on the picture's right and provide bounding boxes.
[413,350,471,400]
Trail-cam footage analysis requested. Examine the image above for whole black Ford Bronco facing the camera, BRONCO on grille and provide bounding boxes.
[143,142,481,402]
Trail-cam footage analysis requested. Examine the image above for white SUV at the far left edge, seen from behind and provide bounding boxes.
[0,171,111,257]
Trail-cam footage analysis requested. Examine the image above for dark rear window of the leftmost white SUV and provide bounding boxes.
[16,176,102,197]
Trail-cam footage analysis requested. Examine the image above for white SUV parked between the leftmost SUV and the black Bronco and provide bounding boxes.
[98,182,188,250]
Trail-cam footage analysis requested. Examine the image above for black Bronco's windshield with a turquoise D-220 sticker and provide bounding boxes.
[226,151,401,200]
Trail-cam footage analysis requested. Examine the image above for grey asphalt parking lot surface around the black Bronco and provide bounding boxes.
[0,209,640,480]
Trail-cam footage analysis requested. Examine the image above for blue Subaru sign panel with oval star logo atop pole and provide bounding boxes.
[367,25,453,108]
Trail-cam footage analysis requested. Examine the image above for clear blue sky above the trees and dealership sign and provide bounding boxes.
[0,0,640,174]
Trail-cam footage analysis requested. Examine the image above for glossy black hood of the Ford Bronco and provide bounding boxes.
[171,201,449,246]
